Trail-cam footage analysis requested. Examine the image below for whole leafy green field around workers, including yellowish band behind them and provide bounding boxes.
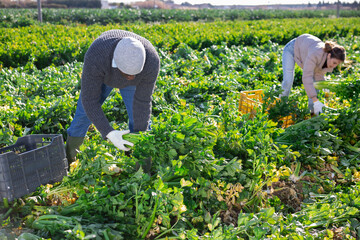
[0,10,360,240]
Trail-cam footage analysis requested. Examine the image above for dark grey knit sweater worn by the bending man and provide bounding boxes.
[81,30,160,139]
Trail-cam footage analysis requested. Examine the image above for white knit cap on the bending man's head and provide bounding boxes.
[112,37,146,75]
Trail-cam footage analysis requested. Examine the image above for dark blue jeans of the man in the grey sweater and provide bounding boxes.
[67,84,136,137]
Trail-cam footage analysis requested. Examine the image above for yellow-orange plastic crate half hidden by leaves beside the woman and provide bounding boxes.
[239,89,294,128]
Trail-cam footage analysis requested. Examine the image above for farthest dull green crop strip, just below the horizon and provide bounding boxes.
[0,9,360,27]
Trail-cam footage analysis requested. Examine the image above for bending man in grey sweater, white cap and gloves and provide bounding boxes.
[66,30,160,163]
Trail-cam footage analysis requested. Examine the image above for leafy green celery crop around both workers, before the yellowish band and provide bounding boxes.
[0,37,360,240]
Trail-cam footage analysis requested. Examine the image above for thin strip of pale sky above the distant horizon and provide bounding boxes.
[108,0,355,5]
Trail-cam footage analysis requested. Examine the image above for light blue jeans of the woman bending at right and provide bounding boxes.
[280,39,318,112]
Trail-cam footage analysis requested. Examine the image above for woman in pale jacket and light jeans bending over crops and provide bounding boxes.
[280,34,346,115]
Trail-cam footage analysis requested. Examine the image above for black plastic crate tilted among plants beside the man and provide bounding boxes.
[0,134,68,201]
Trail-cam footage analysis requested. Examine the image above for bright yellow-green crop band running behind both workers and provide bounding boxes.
[0,18,360,69]
